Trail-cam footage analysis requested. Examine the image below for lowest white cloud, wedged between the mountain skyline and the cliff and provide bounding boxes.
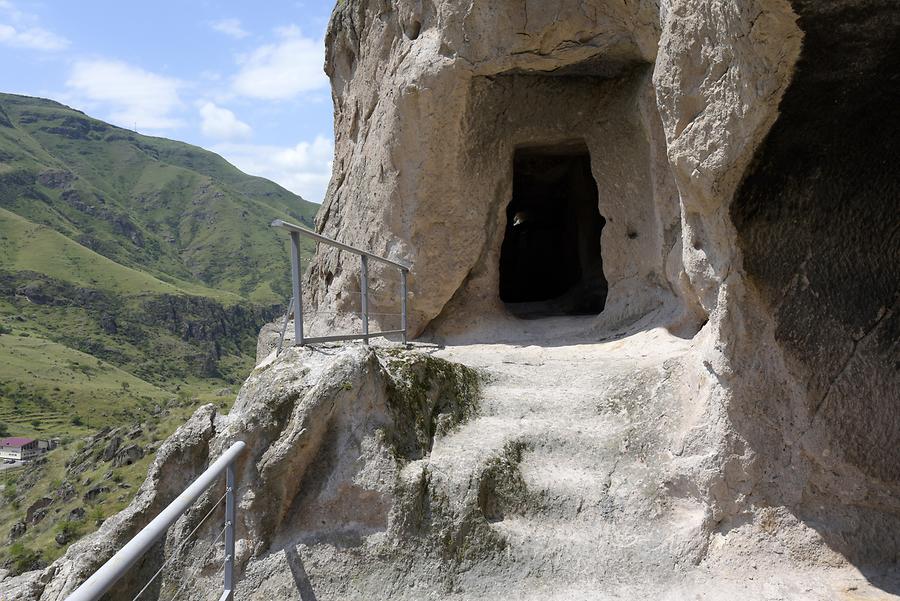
[213,136,334,202]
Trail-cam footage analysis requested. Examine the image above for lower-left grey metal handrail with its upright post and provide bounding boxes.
[66,442,247,601]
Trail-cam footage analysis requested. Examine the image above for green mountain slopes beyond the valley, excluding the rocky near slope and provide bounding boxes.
[0,93,318,436]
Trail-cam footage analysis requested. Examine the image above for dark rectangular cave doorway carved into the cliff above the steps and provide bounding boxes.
[500,144,608,318]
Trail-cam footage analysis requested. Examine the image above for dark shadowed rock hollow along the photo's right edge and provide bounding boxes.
[730,0,900,562]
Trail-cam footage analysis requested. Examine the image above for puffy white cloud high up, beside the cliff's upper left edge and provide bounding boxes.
[233,26,328,100]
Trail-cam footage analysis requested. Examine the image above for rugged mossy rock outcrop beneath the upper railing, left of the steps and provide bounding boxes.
[0,347,479,600]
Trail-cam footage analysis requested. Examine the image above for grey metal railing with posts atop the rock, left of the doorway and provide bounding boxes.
[272,219,410,346]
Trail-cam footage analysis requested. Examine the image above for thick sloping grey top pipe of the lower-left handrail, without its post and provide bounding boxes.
[66,441,247,601]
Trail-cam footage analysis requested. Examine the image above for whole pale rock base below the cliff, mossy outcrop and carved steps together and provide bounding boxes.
[0,336,890,601]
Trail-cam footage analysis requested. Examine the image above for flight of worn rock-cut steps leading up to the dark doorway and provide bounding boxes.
[419,330,704,599]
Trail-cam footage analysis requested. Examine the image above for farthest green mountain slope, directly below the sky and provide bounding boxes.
[0,94,318,302]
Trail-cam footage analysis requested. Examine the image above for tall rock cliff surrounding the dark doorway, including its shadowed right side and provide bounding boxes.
[298,0,900,563]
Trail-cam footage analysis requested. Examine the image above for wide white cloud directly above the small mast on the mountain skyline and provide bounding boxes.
[66,60,183,130]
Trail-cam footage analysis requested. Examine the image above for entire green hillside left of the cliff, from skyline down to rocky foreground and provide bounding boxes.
[0,94,318,572]
